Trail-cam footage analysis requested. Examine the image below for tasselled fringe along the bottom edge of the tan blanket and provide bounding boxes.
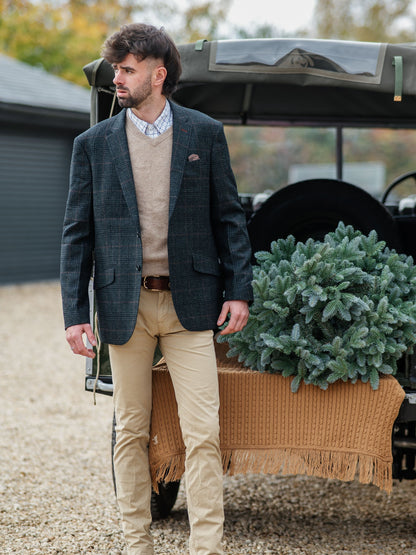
[151,448,392,493]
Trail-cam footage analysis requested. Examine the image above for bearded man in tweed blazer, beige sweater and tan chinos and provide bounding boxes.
[61,24,252,555]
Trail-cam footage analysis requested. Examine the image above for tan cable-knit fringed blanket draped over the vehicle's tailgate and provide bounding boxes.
[149,361,404,492]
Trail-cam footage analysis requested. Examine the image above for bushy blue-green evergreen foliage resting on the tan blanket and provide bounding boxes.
[219,222,416,391]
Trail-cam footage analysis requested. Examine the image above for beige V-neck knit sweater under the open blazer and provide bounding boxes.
[126,117,172,276]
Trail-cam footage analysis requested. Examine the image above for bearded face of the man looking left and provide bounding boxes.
[113,54,156,108]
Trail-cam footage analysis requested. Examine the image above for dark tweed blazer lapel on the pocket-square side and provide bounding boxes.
[169,102,192,218]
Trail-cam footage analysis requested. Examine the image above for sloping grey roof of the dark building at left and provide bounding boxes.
[0,53,90,113]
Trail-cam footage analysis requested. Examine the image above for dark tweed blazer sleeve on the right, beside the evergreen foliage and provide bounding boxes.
[211,124,253,302]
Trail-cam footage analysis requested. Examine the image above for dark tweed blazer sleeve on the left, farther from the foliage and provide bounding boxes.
[61,135,94,329]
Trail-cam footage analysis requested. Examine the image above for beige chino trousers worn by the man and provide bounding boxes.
[109,287,224,555]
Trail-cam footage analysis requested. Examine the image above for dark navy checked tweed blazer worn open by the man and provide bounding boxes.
[61,103,252,345]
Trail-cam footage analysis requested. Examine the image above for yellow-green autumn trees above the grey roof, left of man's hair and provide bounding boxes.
[0,0,142,85]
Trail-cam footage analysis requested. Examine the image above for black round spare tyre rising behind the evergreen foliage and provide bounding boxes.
[248,179,401,253]
